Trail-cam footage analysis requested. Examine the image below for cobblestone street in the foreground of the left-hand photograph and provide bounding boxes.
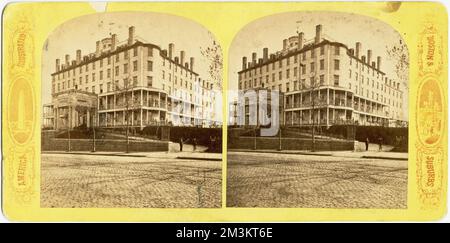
[41,154,222,208]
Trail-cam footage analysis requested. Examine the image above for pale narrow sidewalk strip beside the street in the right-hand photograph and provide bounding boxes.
[228,149,408,160]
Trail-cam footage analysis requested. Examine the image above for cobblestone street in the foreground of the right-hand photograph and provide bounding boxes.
[227,152,408,208]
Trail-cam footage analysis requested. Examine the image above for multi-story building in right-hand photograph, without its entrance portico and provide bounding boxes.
[238,25,404,126]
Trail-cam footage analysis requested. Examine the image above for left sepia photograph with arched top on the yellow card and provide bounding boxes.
[39,12,222,208]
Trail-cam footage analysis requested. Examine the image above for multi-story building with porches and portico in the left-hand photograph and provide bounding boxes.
[43,27,219,129]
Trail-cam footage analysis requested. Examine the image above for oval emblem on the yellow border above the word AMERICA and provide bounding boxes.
[7,77,34,144]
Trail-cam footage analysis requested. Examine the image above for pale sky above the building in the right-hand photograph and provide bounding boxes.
[228,11,408,120]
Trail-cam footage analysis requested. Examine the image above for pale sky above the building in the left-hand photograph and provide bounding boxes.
[42,12,221,110]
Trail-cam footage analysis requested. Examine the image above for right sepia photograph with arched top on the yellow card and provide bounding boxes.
[226,12,410,208]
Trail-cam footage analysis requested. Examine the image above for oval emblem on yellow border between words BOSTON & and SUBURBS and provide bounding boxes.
[417,78,445,145]
